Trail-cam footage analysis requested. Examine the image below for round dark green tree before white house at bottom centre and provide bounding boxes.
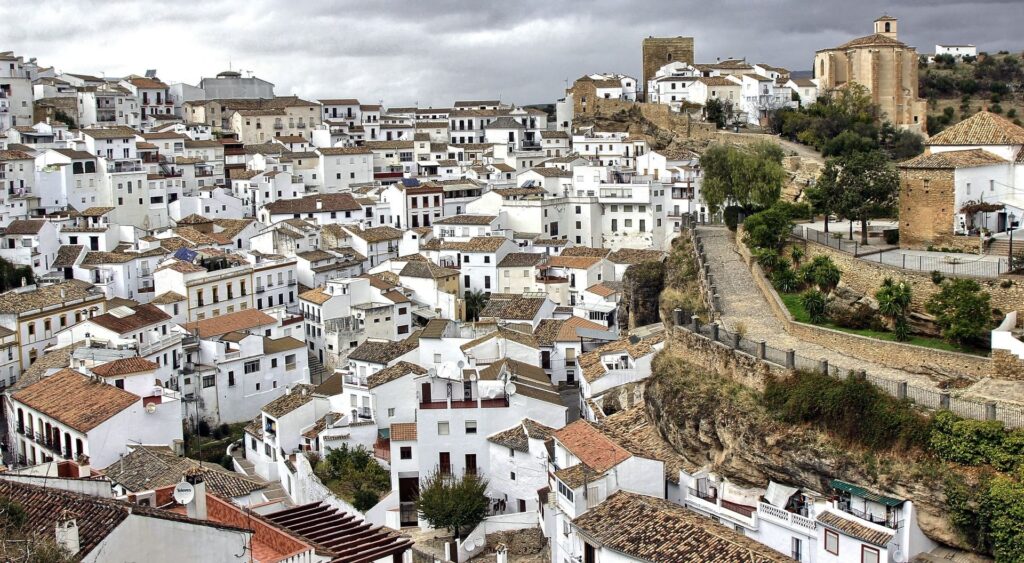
[416,471,488,538]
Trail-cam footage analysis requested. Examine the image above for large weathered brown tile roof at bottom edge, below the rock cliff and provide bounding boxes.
[572,491,792,563]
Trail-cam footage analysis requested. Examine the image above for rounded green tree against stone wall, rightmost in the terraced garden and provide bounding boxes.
[925,278,992,344]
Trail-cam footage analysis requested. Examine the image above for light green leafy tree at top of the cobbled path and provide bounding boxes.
[700,141,785,212]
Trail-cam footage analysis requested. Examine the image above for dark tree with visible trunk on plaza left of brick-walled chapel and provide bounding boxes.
[836,150,899,245]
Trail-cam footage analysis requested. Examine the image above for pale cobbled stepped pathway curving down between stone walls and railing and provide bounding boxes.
[697,227,954,388]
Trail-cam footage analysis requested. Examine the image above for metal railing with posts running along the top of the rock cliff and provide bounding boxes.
[674,309,1024,428]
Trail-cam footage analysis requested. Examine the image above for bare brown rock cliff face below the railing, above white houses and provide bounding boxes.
[645,352,970,549]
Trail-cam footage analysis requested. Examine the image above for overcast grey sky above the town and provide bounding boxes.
[0,0,1024,107]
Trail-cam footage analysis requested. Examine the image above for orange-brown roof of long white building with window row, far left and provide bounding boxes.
[11,370,139,433]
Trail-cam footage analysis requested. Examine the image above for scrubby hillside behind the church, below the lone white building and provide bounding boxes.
[919,51,1024,135]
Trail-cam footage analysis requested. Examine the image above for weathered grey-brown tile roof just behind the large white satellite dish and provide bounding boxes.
[102,445,266,499]
